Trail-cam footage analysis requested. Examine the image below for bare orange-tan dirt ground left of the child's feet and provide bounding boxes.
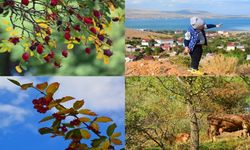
[125,60,192,76]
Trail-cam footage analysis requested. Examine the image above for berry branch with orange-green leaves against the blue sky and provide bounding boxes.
[8,79,122,150]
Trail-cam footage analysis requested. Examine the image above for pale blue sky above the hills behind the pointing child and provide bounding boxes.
[126,0,250,15]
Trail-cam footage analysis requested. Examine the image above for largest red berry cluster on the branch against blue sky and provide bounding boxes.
[32,97,52,113]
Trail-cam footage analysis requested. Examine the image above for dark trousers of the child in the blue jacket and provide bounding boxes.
[190,45,202,70]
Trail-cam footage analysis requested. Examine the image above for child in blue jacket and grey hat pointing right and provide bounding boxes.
[184,17,222,75]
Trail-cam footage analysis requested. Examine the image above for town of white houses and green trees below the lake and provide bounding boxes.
[125,30,250,62]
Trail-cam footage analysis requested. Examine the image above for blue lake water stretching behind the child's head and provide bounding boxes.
[125,18,250,31]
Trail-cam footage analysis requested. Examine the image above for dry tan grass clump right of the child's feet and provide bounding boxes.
[201,55,238,75]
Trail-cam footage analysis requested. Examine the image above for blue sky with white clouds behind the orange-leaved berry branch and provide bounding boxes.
[0,77,125,150]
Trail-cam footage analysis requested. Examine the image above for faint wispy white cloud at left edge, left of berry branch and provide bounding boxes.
[0,103,29,129]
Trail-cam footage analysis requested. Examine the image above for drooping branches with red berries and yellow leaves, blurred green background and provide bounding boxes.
[0,0,124,73]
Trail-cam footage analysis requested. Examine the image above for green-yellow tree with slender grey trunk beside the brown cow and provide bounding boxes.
[126,77,250,149]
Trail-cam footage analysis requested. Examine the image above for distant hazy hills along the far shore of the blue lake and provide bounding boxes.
[126,9,250,18]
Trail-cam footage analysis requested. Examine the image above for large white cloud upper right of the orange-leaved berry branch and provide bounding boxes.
[49,77,125,112]
